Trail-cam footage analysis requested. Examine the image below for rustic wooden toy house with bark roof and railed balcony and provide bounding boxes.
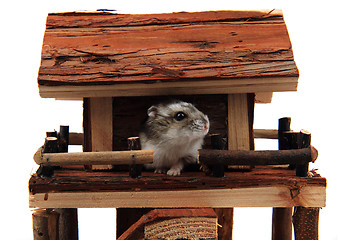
[29,10,326,240]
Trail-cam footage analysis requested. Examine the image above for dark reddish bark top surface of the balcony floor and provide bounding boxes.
[29,166,326,194]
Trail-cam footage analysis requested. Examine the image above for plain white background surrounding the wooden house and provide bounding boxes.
[0,0,360,240]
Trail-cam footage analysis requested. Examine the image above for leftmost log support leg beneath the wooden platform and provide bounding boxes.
[32,209,59,240]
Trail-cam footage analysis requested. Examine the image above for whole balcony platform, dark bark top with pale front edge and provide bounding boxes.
[29,167,326,208]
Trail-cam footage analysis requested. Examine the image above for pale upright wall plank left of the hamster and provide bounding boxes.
[89,97,113,170]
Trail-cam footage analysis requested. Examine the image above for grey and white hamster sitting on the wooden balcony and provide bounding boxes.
[139,101,210,176]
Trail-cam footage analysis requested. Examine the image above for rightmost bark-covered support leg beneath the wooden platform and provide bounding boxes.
[293,207,320,240]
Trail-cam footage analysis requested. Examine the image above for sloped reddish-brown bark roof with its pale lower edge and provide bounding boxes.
[38,11,299,99]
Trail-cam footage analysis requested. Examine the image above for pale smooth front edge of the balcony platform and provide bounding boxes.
[30,186,325,208]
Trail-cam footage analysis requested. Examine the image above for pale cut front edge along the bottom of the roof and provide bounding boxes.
[39,77,297,100]
